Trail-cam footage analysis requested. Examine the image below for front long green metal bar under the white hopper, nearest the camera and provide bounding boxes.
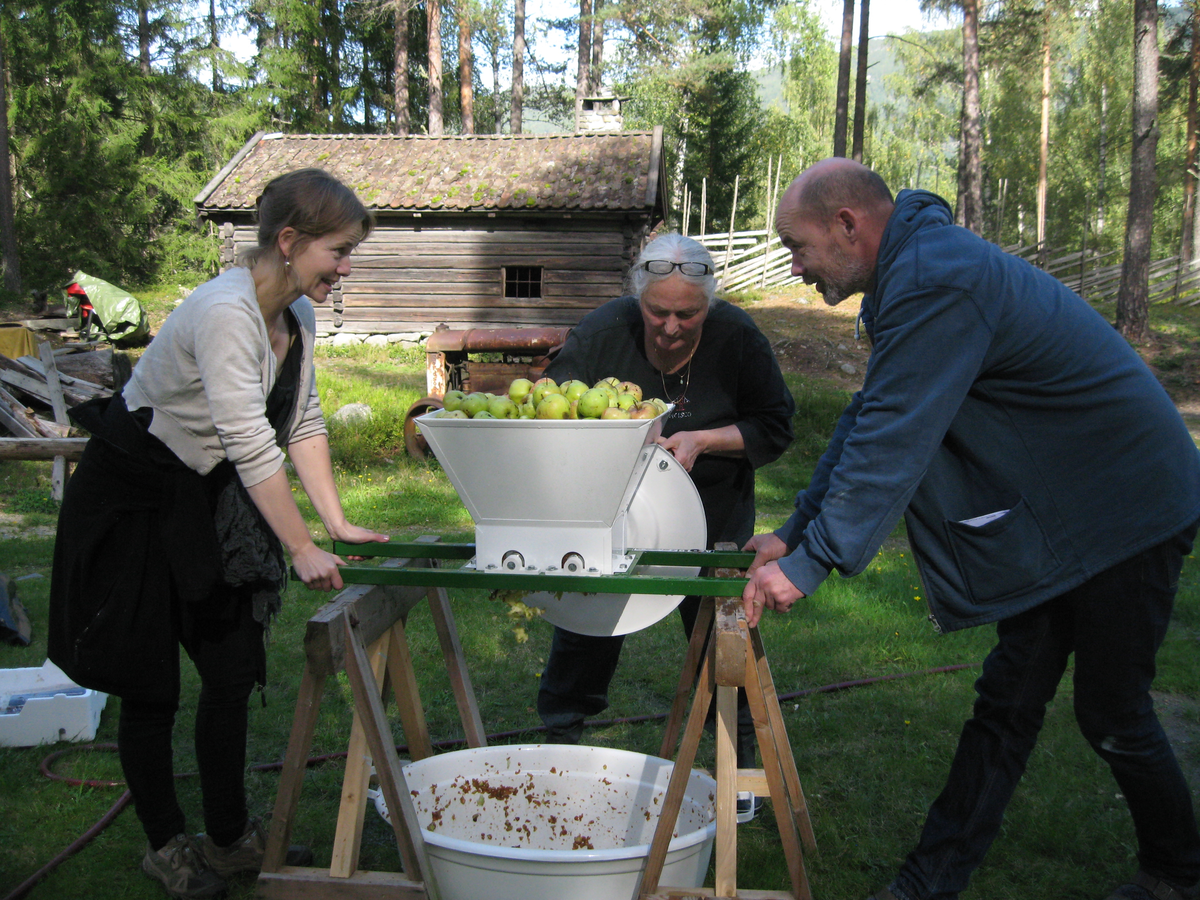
[340,565,746,596]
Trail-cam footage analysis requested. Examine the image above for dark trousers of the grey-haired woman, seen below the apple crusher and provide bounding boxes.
[538,596,755,768]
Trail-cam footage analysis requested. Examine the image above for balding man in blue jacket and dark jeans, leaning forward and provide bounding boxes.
[743,158,1200,900]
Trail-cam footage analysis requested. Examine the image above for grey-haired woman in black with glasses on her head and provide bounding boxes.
[538,234,794,801]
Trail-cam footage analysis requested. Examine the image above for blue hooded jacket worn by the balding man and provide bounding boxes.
[776,191,1200,631]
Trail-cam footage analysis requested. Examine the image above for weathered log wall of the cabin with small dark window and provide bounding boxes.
[226,218,643,334]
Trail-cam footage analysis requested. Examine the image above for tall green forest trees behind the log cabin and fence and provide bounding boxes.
[0,0,1200,338]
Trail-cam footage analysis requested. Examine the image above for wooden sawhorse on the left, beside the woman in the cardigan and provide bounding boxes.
[258,538,486,900]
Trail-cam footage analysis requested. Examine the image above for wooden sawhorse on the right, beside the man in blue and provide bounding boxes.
[641,561,816,900]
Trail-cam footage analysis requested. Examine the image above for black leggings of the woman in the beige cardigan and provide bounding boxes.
[116,602,265,850]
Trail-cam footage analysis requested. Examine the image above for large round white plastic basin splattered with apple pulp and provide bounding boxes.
[393,744,716,900]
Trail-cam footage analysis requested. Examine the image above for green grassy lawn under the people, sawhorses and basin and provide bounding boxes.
[0,300,1200,900]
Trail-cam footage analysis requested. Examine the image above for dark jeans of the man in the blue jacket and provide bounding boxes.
[894,529,1200,900]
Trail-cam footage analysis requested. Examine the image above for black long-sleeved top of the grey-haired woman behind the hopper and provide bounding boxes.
[546,296,796,546]
